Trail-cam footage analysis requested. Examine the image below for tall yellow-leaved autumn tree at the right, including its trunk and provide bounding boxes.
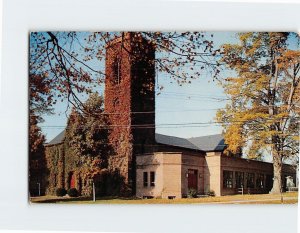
[217,32,300,193]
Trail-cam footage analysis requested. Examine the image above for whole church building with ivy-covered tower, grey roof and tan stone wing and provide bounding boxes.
[46,33,296,198]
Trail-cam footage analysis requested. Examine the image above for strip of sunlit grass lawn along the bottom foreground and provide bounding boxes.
[30,192,298,204]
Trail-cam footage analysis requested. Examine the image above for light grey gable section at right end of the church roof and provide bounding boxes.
[188,134,226,151]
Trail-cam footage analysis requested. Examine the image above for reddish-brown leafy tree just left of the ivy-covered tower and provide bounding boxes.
[65,93,111,193]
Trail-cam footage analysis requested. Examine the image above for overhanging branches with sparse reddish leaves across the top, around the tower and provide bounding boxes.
[29,32,219,114]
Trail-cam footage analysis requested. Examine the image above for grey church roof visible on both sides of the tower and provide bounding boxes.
[47,130,226,151]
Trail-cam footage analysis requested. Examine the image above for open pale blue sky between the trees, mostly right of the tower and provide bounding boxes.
[40,32,298,141]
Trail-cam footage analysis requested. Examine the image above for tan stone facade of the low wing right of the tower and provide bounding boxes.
[136,151,296,198]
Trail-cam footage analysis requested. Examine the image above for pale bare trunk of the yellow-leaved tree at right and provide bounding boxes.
[270,150,282,194]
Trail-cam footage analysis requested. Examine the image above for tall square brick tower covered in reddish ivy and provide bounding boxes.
[105,32,155,194]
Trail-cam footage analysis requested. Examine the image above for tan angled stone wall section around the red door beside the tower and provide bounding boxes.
[136,152,204,198]
